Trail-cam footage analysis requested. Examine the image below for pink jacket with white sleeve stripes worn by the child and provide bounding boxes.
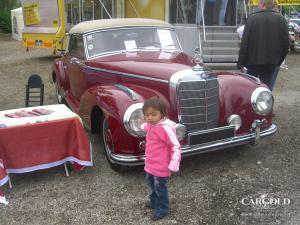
[142,119,181,177]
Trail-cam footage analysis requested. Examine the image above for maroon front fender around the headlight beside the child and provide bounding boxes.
[79,84,163,154]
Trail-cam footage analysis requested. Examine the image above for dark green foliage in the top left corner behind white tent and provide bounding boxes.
[0,0,21,33]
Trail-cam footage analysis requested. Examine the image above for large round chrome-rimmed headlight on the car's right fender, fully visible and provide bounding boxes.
[251,87,274,116]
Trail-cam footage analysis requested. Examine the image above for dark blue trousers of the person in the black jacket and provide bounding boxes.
[246,65,275,90]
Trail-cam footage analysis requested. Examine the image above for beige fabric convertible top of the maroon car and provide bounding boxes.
[69,18,172,34]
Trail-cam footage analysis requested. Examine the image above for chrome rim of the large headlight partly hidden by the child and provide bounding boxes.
[123,103,146,137]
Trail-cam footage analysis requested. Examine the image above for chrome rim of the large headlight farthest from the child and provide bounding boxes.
[251,87,274,116]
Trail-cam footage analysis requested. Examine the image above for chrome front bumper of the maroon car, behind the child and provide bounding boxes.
[108,120,277,166]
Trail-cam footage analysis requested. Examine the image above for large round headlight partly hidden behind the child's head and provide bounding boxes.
[123,103,146,137]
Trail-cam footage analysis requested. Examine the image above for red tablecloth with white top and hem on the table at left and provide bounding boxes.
[0,105,93,192]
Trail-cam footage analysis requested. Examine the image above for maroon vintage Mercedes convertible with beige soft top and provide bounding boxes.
[52,19,277,170]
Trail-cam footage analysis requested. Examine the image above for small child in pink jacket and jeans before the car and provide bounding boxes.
[142,97,181,220]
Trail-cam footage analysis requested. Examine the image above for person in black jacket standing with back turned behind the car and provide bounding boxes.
[237,0,289,89]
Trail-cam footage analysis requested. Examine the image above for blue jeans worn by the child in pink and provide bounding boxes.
[146,172,169,216]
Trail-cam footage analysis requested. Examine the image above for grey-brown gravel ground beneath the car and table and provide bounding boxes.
[0,34,300,225]
